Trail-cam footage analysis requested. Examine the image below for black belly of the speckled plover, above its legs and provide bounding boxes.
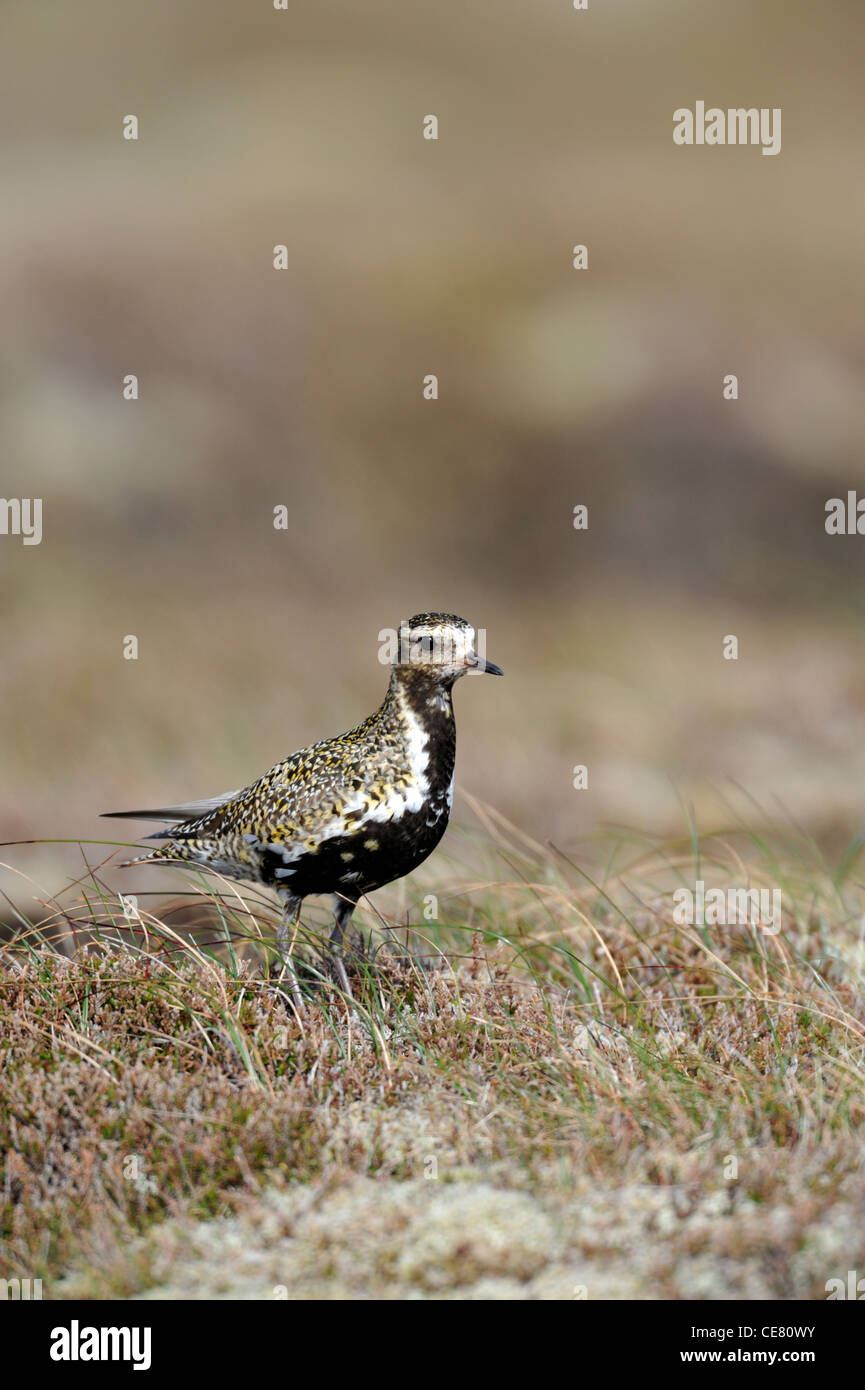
[260,805,448,899]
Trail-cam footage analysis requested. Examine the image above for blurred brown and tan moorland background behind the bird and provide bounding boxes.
[0,0,865,895]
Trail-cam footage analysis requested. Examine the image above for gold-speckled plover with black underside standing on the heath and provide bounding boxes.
[104,613,503,1005]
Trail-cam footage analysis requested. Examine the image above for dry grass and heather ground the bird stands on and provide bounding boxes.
[0,808,865,1298]
